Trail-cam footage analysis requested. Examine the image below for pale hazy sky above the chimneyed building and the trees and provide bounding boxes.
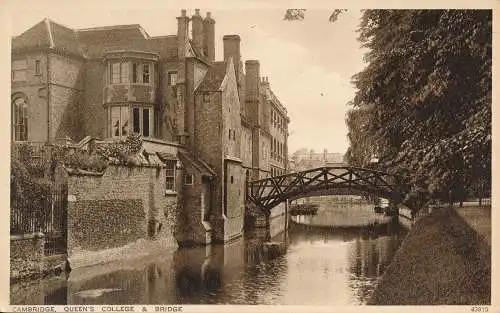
[5,0,366,153]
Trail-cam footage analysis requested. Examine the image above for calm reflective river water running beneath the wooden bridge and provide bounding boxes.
[11,202,405,305]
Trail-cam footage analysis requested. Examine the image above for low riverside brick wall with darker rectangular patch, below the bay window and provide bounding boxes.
[68,165,177,258]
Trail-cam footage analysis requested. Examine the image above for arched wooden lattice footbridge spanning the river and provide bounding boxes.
[247,166,410,212]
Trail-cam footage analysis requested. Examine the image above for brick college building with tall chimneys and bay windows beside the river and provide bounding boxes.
[11,9,289,244]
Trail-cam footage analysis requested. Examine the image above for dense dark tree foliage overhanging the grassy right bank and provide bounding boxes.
[347,10,492,198]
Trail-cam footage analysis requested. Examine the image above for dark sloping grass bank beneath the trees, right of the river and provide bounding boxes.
[369,209,491,305]
